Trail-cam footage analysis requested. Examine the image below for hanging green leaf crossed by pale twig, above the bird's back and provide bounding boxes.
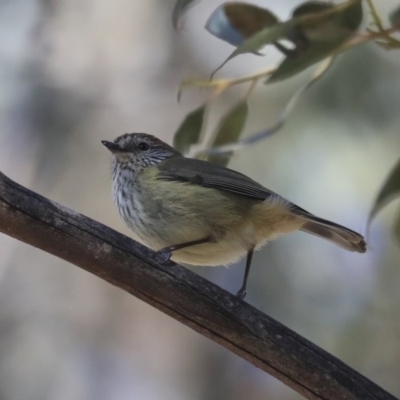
[207,101,249,167]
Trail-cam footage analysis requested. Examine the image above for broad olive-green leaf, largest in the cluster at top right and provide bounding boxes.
[267,0,362,83]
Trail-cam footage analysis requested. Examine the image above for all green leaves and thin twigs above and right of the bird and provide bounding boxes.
[173,0,400,244]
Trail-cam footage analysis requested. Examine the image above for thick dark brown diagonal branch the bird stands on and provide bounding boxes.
[0,173,395,400]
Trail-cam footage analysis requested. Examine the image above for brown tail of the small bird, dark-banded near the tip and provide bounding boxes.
[300,213,367,253]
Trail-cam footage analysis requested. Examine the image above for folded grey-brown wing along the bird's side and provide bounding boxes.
[158,157,278,200]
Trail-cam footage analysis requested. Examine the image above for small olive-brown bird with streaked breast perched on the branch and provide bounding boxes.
[102,133,366,298]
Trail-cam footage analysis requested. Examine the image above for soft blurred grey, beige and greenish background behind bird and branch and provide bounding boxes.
[0,0,400,400]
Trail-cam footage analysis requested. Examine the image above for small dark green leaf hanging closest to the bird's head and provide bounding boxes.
[174,105,206,154]
